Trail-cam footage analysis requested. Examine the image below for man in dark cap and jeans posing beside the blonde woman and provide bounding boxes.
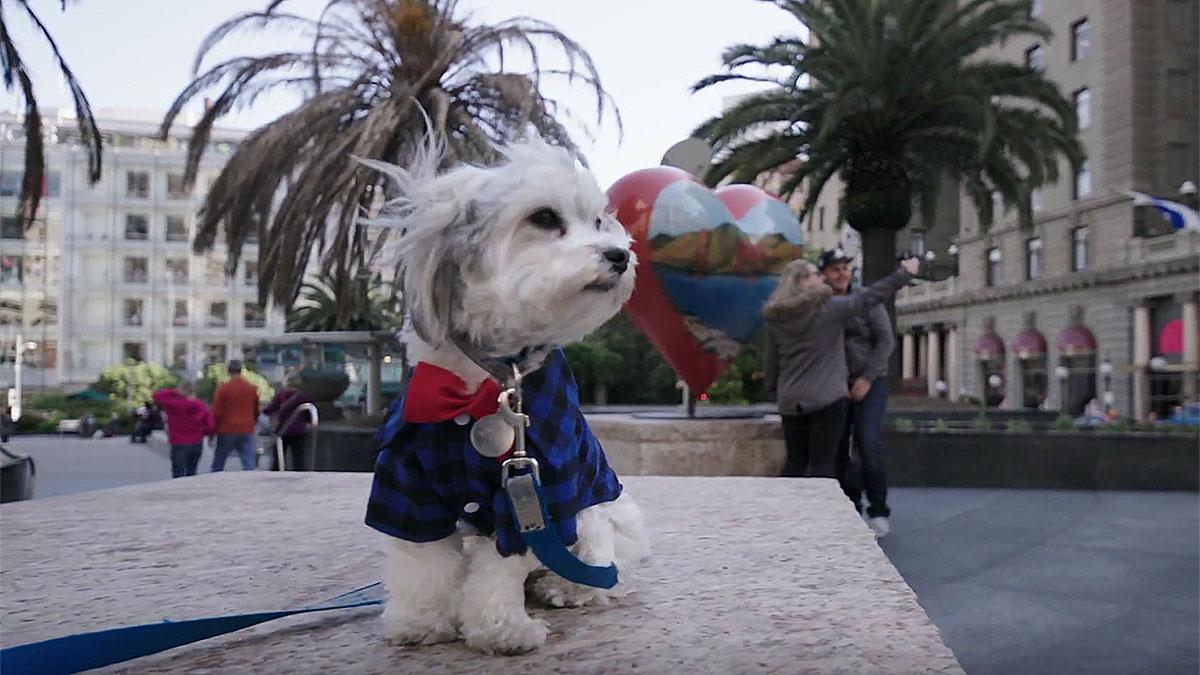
[817,249,895,537]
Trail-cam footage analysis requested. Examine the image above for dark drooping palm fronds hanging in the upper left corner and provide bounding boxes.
[0,0,102,228]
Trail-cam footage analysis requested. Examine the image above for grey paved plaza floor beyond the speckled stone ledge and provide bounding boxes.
[8,437,1200,674]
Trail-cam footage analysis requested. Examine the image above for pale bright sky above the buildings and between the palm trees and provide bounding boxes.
[0,0,799,189]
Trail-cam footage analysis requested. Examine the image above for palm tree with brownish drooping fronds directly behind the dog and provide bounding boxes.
[161,0,619,318]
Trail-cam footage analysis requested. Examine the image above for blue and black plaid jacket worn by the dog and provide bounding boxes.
[366,350,622,556]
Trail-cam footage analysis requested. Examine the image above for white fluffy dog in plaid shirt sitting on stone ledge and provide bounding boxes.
[366,139,648,653]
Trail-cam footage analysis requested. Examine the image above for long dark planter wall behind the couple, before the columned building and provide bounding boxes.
[883,431,1200,491]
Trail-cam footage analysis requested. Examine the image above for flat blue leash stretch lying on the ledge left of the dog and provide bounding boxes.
[0,583,384,675]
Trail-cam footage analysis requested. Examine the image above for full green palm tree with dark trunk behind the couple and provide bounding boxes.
[692,0,1084,282]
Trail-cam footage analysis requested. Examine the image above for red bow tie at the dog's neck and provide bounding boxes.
[402,362,500,424]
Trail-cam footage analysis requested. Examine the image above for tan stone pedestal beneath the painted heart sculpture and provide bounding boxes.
[588,414,787,476]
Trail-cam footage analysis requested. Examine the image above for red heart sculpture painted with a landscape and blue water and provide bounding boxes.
[608,167,802,396]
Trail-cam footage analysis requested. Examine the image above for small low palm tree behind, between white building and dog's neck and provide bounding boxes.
[287,269,403,331]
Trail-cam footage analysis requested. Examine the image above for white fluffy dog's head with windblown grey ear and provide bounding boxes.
[368,139,636,357]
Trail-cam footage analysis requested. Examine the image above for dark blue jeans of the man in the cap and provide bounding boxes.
[838,377,892,518]
